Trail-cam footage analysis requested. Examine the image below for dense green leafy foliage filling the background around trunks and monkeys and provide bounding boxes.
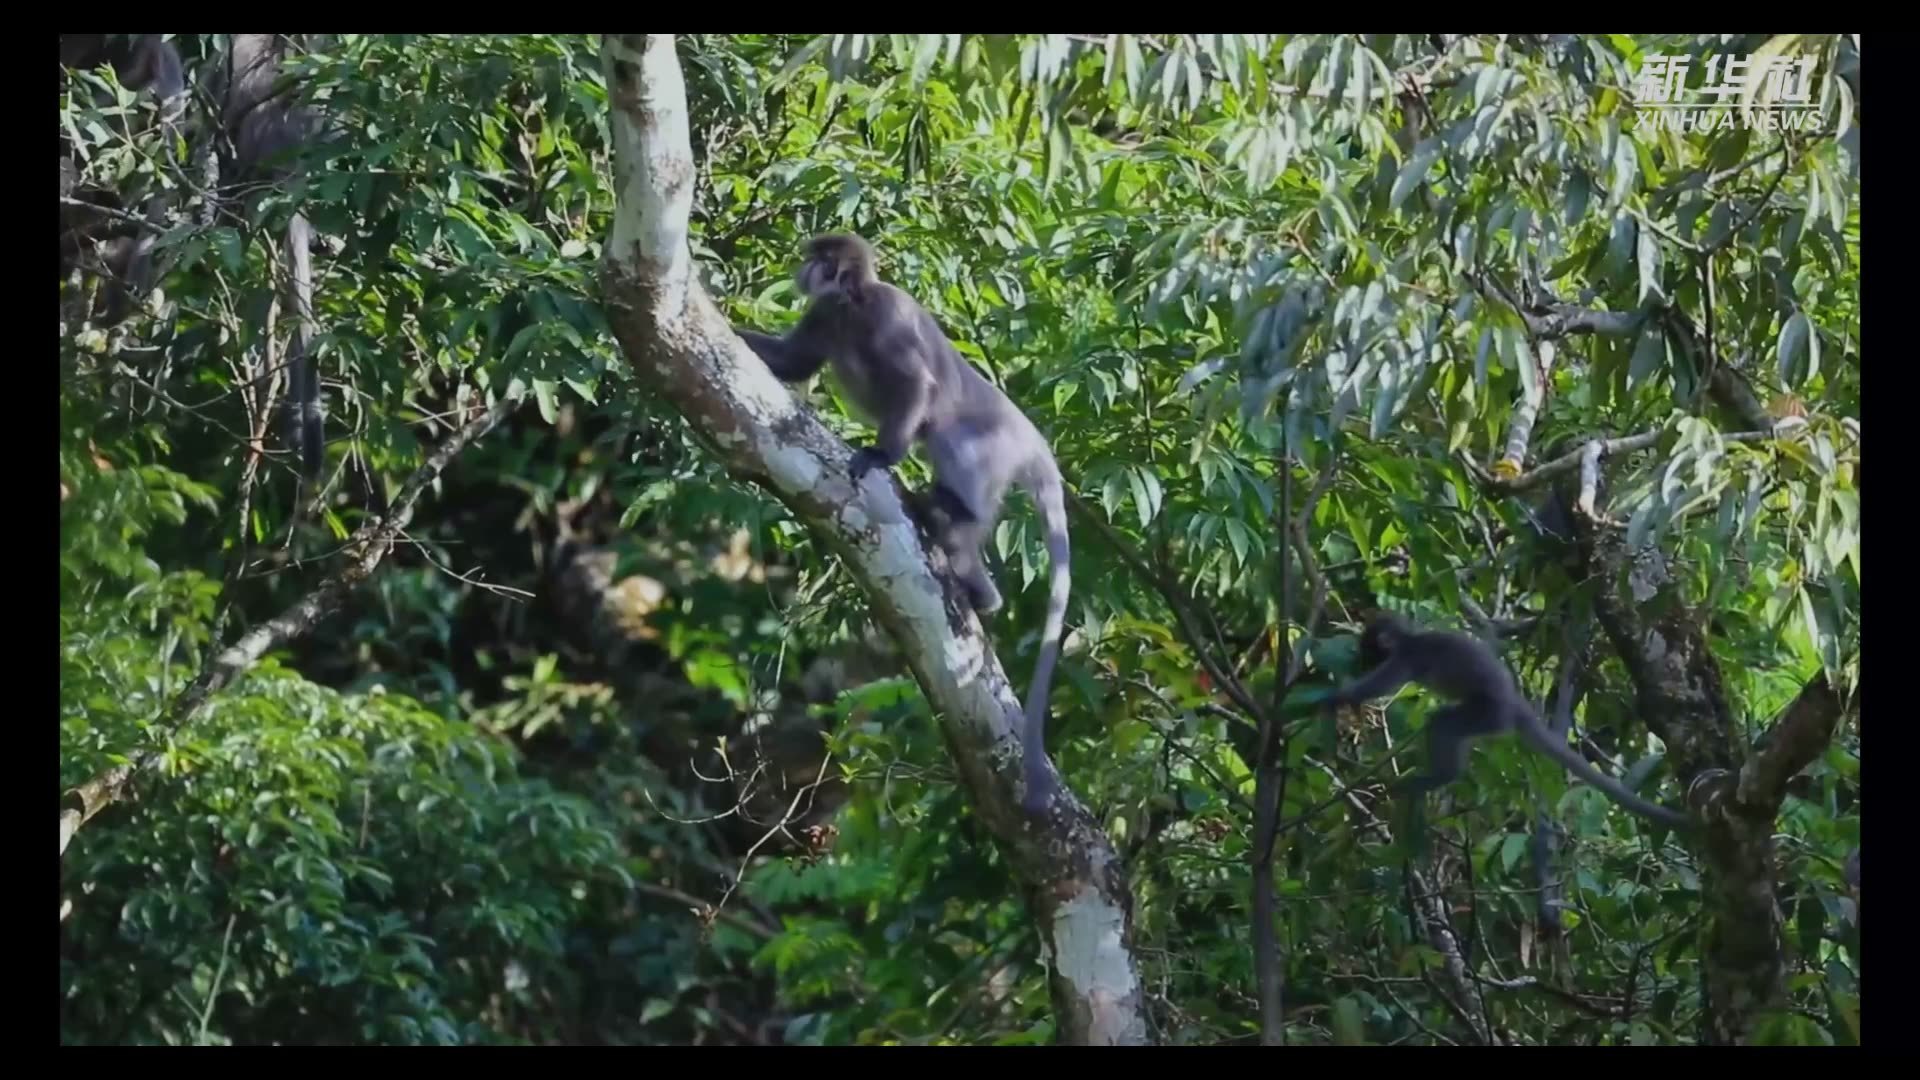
[60,35,1860,1043]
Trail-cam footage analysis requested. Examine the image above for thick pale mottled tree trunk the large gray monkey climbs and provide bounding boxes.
[601,35,1148,1043]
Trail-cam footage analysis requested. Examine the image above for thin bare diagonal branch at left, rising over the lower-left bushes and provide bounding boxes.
[60,390,516,855]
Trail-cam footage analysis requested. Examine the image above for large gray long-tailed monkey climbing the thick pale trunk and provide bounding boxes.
[735,234,1069,815]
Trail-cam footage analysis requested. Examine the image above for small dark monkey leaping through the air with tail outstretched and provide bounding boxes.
[1327,613,1690,828]
